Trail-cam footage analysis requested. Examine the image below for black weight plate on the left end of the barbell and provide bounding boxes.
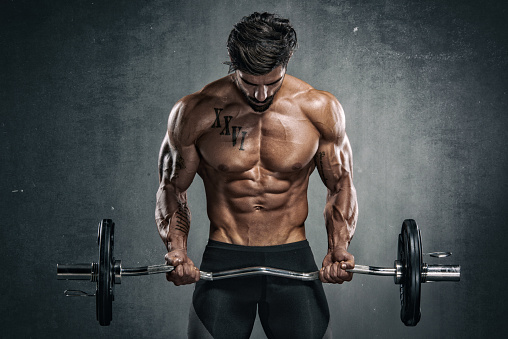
[96,219,115,326]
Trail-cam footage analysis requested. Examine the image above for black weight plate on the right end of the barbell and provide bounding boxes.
[397,219,423,326]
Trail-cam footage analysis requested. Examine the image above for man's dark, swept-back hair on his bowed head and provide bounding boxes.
[225,12,296,75]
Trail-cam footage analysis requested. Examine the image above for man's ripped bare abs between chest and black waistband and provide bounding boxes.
[200,161,313,246]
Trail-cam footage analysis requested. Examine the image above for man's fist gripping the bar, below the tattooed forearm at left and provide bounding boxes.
[164,250,199,286]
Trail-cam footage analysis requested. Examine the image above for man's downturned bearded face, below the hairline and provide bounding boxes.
[235,66,286,112]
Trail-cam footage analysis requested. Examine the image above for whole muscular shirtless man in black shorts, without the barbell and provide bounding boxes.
[156,13,357,339]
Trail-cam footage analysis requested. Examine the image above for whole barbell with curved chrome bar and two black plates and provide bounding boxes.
[57,219,460,326]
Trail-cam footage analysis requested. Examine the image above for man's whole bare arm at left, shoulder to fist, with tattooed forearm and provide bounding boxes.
[155,102,199,285]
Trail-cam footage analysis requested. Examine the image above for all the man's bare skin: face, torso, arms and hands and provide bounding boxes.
[155,67,358,285]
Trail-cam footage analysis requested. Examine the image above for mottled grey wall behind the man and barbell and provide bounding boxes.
[0,0,508,338]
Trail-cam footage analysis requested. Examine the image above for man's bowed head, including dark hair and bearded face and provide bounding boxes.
[228,12,296,112]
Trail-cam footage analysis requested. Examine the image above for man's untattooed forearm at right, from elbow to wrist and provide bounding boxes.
[324,187,358,251]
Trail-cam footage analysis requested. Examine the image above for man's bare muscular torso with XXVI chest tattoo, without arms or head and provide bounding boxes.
[181,75,332,246]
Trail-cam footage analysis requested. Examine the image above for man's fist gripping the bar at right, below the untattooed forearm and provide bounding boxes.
[319,249,355,284]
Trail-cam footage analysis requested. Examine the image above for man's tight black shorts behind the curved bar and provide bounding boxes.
[189,240,330,339]
